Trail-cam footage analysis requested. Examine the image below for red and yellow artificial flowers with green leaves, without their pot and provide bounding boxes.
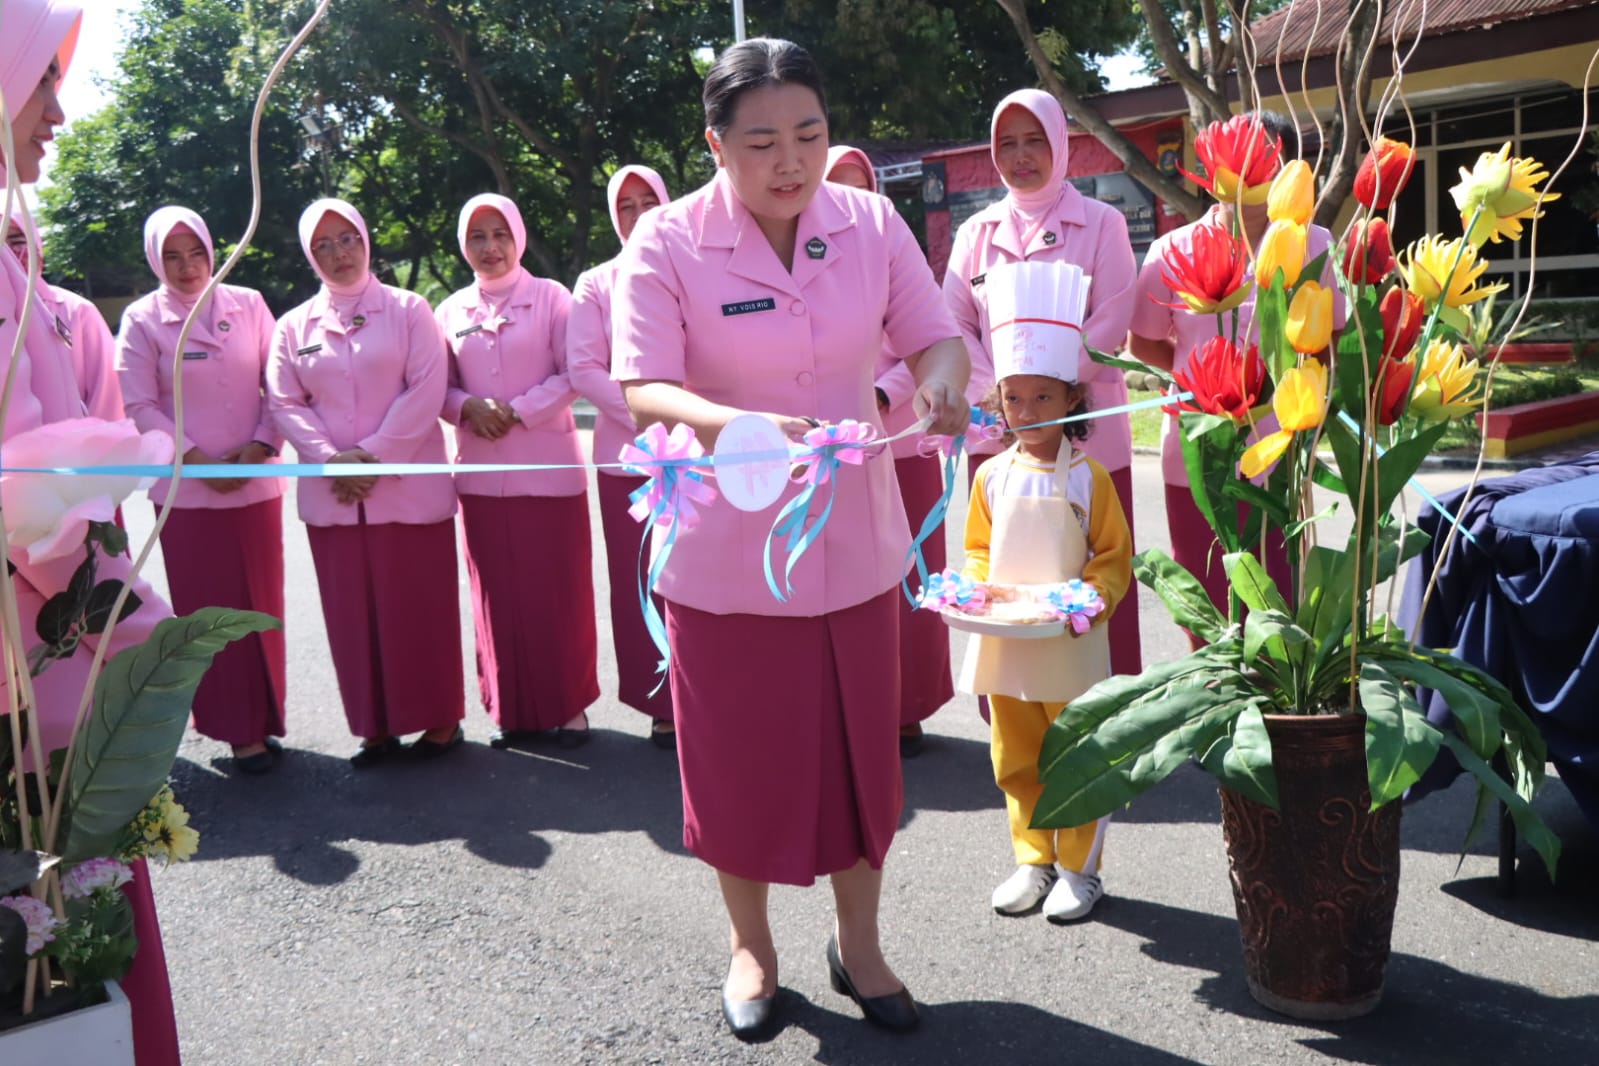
[1036,115,1559,875]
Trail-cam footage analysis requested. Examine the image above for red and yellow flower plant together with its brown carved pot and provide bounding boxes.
[1035,118,1559,1018]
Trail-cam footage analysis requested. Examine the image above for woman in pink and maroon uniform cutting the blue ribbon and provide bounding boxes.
[612,38,967,1039]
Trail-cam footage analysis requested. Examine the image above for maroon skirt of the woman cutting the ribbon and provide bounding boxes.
[667,588,903,885]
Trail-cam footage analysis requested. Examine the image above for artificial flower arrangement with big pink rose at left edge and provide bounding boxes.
[0,419,280,1029]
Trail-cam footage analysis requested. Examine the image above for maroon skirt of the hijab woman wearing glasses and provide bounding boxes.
[305,508,467,740]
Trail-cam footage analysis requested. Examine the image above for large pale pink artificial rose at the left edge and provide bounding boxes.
[0,419,173,563]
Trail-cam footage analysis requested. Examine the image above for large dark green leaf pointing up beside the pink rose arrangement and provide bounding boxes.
[61,607,281,863]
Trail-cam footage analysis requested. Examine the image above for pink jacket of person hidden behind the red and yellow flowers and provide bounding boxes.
[1129,205,1348,484]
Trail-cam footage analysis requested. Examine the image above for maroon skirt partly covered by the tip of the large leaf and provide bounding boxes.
[161,497,288,746]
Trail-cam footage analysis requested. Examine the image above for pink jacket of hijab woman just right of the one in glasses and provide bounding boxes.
[435,273,588,495]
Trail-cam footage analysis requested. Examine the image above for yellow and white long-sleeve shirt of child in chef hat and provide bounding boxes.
[963,447,1132,625]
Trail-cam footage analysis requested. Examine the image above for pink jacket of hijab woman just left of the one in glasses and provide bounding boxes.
[117,284,283,508]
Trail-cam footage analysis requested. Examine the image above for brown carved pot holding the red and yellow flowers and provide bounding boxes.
[1220,714,1399,1021]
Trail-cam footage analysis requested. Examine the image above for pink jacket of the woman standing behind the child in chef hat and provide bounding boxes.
[943,185,1138,470]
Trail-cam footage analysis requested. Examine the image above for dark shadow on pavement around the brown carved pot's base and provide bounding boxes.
[1094,898,1599,1066]
